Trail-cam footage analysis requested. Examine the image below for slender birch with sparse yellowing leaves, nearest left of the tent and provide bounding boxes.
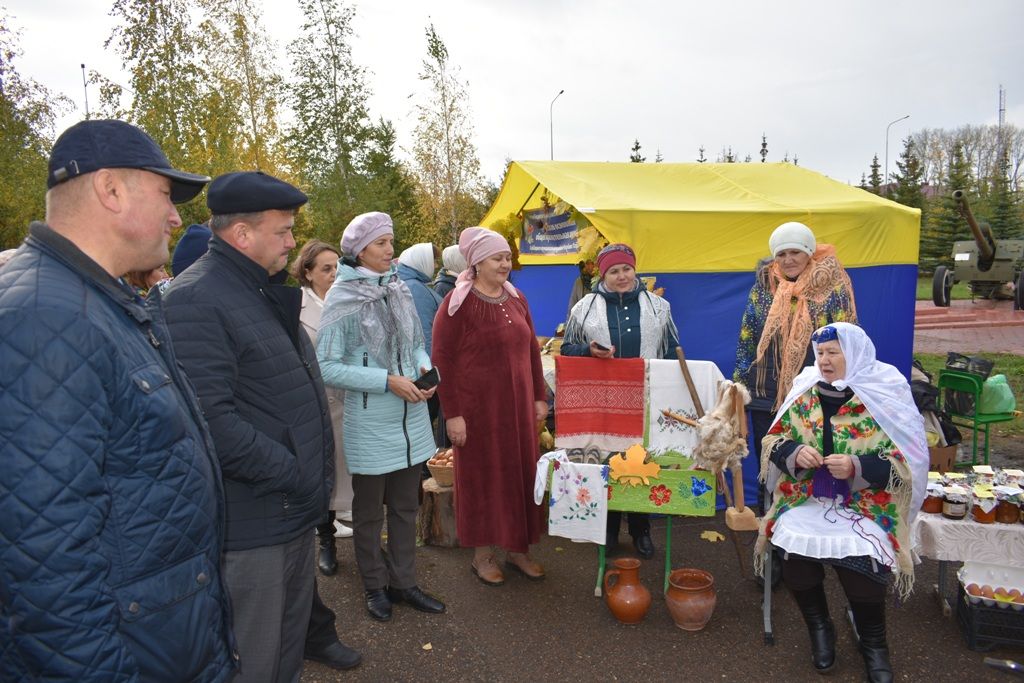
[413,24,482,242]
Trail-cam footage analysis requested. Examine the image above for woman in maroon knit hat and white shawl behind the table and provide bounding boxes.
[560,244,679,559]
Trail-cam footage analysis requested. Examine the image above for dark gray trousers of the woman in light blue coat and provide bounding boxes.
[352,465,423,591]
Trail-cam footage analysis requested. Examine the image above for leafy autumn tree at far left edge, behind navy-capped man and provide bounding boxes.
[0,12,71,250]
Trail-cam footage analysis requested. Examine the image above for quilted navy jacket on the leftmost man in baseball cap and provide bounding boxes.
[0,223,234,682]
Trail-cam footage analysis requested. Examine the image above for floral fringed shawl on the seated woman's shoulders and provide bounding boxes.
[755,386,913,599]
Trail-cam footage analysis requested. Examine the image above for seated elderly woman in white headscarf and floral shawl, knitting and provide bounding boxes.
[756,323,929,681]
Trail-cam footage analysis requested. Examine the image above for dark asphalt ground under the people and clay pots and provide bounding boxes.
[302,515,1011,682]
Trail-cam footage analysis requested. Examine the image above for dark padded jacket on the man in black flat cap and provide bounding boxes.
[164,236,334,550]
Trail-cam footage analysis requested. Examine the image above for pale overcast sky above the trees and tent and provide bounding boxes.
[8,0,1024,183]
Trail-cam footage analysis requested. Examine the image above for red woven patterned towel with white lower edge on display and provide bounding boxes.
[555,355,644,452]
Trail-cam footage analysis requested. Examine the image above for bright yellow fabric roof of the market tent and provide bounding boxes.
[481,161,921,272]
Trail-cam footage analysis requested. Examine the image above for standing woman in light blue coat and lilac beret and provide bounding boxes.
[316,212,444,622]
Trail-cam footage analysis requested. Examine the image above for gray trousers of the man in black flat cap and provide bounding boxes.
[224,529,316,683]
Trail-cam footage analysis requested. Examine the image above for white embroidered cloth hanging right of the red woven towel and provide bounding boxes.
[647,359,725,456]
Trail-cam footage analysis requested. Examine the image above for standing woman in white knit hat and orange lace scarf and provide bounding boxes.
[732,222,857,509]
